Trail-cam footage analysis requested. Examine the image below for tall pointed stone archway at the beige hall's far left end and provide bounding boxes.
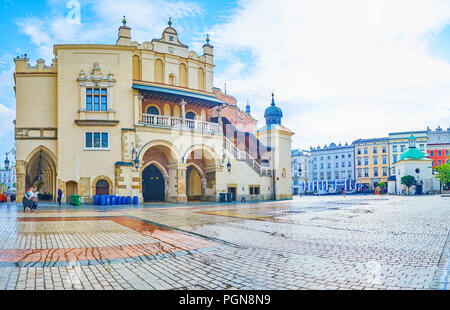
[23,147,56,201]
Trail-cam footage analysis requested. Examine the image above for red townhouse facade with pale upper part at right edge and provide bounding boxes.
[427,126,450,168]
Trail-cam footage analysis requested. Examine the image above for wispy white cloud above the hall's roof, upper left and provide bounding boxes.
[17,0,202,61]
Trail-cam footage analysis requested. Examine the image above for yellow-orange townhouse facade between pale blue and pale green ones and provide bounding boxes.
[353,137,389,190]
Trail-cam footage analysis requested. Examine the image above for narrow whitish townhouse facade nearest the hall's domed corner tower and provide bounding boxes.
[291,149,311,195]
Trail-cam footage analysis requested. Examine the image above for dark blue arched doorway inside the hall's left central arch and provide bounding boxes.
[142,165,165,202]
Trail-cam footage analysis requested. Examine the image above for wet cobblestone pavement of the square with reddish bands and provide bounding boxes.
[0,196,450,290]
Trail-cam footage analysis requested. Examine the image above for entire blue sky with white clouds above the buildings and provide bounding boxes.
[0,0,450,166]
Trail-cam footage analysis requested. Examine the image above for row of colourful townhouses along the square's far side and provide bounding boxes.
[291,127,450,195]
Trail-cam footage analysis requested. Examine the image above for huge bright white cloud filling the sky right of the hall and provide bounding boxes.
[210,0,450,147]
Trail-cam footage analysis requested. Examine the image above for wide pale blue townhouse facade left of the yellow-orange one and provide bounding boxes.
[306,143,356,194]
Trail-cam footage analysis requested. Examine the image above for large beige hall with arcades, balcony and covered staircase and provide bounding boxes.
[14,20,293,203]
